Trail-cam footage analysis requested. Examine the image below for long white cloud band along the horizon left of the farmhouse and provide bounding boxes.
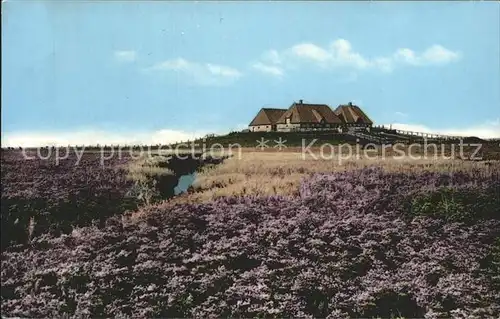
[2,129,208,147]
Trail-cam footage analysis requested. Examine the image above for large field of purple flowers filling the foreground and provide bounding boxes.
[2,169,500,318]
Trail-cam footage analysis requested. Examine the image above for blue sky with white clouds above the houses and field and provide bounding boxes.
[2,1,500,145]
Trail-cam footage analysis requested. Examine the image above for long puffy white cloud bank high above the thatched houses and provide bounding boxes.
[261,39,462,74]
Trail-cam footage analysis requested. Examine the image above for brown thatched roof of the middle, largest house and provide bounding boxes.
[278,102,342,124]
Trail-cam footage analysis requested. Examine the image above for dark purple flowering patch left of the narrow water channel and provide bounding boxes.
[1,151,138,248]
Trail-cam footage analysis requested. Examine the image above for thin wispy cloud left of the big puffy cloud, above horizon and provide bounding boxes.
[148,58,243,85]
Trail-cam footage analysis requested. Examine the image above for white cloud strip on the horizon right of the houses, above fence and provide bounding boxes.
[385,119,500,138]
